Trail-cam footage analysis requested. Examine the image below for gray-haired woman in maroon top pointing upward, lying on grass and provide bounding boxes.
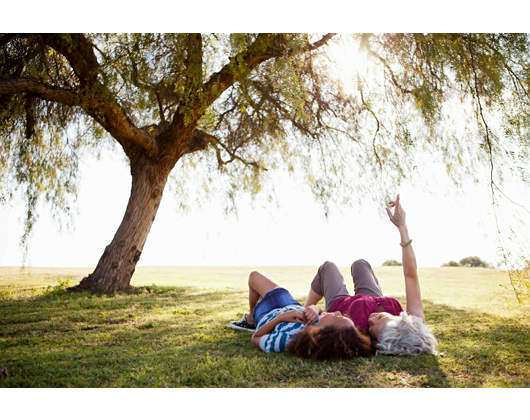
[291,195,437,355]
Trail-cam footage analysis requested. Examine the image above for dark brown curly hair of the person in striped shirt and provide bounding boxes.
[286,325,373,360]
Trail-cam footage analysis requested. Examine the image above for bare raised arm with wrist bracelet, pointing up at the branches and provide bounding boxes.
[386,194,425,322]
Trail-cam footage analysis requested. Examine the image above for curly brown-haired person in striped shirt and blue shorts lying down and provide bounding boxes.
[230,271,371,360]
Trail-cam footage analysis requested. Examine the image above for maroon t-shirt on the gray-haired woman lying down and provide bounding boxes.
[329,295,404,332]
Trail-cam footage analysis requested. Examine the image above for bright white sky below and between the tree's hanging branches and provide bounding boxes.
[0,39,530,267]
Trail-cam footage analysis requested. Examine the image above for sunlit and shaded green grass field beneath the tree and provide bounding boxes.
[0,267,530,388]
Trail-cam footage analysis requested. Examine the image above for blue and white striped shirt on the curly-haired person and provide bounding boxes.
[256,305,320,353]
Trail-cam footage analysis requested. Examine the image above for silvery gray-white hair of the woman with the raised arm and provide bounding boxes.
[376,312,438,356]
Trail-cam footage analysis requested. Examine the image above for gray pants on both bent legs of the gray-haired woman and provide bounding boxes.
[311,260,383,311]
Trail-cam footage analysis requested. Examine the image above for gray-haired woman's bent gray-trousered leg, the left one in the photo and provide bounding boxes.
[306,261,350,311]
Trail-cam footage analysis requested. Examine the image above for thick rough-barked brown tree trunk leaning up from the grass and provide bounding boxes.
[71,158,169,293]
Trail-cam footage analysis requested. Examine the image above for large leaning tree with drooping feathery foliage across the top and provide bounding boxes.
[0,33,530,292]
